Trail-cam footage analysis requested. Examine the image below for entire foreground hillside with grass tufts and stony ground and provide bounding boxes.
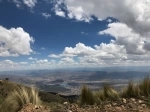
[0,78,150,112]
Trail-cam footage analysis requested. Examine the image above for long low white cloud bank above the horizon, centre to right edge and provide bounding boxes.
[48,40,150,67]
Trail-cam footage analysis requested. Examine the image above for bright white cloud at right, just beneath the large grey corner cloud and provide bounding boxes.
[99,23,146,54]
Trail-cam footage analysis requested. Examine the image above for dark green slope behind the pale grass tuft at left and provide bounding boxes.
[0,79,68,112]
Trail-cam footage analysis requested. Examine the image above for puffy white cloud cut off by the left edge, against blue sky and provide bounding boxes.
[0,26,34,57]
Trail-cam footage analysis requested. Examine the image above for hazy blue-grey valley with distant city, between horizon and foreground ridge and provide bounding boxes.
[0,70,149,95]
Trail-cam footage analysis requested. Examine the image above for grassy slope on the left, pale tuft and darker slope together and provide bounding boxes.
[0,80,67,112]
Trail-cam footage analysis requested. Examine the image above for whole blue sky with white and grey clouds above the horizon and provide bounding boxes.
[0,0,150,70]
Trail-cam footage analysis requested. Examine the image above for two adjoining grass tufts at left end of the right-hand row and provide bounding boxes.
[80,84,119,105]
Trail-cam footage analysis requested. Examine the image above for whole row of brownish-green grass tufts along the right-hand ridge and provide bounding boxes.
[79,77,150,106]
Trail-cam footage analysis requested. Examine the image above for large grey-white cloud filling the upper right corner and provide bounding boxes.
[56,0,150,35]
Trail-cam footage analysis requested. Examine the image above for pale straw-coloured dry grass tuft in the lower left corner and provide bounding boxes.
[0,86,41,112]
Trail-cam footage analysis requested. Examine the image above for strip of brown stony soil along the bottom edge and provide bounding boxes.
[19,98,150,112]
